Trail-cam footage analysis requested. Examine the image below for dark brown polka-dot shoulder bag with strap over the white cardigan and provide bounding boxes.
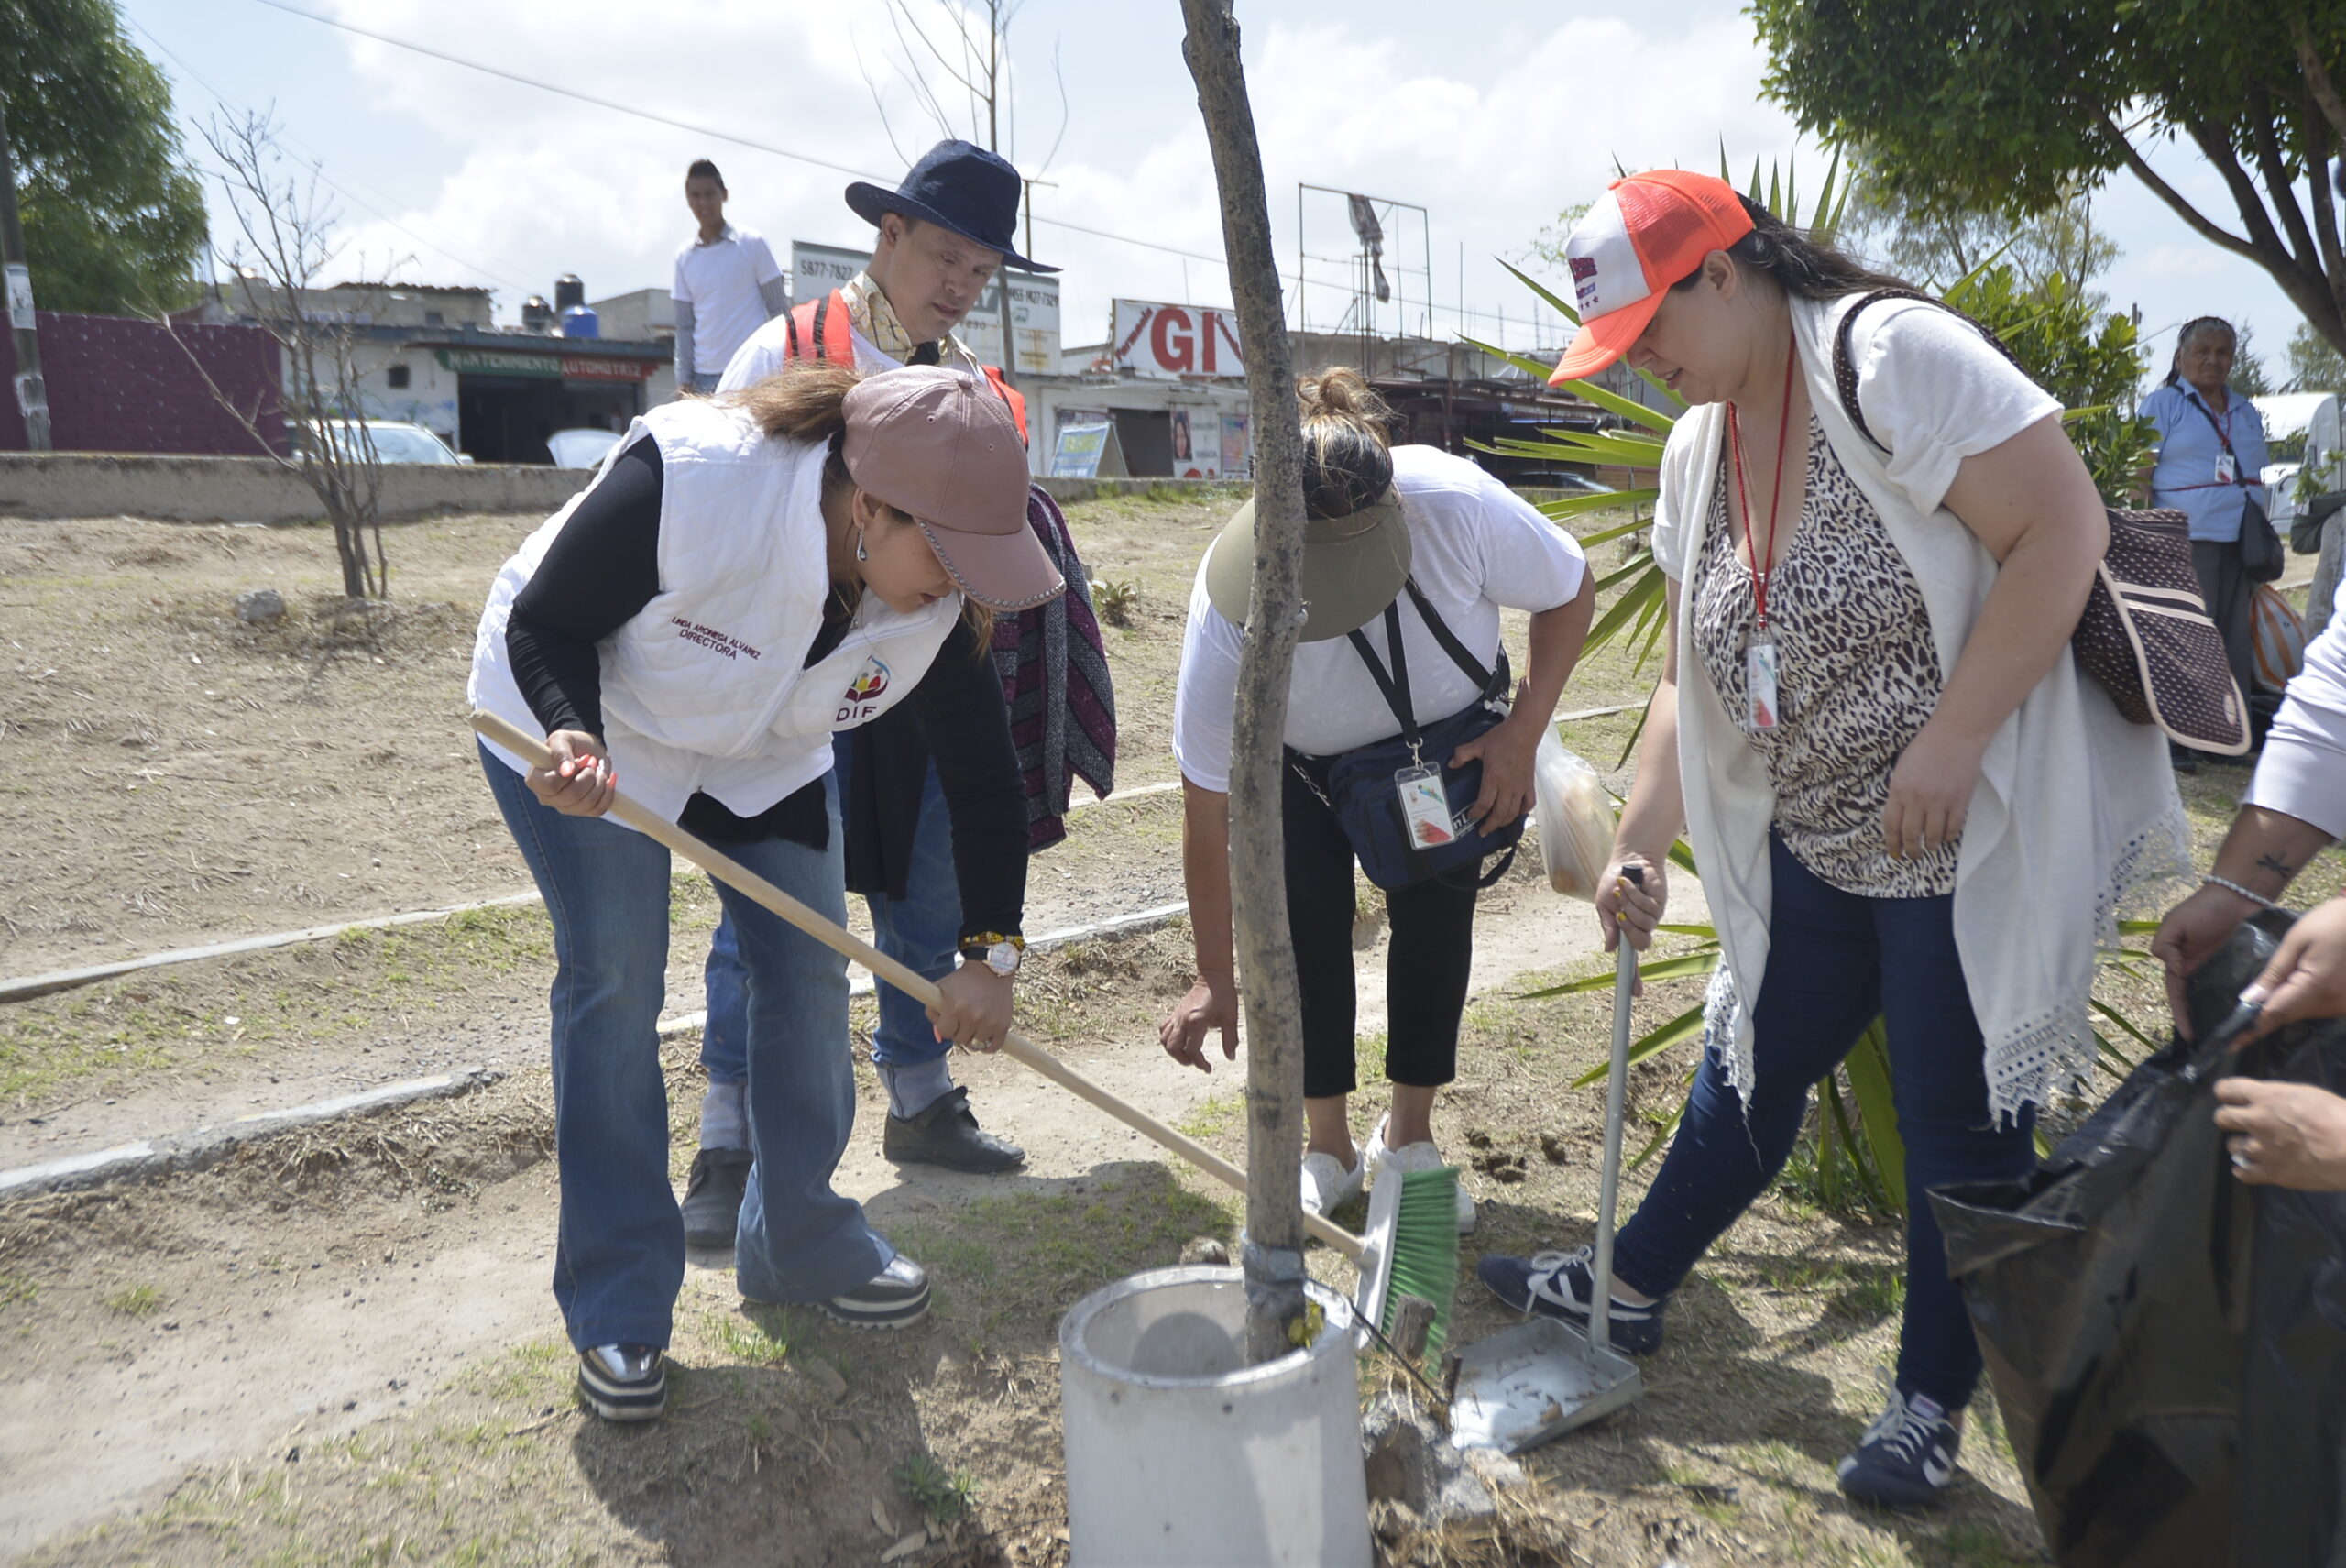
[1832,289,2252,756]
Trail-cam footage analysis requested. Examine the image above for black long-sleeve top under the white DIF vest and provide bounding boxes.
[504,442,1027,937]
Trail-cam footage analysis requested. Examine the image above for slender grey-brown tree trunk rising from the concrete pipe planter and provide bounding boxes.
[1182,0,1304,1362]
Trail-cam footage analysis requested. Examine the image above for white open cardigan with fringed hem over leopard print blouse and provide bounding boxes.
[1654,301,2191,1120]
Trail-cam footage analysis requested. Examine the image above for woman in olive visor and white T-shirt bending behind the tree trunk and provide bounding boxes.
[1159,371,1595,1233]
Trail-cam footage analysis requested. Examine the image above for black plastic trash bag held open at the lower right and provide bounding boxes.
[1931,916,2346,1568]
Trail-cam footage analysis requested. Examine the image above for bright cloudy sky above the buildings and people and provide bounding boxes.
[122,0,2297,382]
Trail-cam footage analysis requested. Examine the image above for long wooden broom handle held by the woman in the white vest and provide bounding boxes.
[472,709,1363,1260]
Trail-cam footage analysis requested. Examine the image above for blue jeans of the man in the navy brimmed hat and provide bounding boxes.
[701,741,962,1084]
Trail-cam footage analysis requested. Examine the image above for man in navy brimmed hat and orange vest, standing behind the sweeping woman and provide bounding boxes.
[685,141,1114,1246]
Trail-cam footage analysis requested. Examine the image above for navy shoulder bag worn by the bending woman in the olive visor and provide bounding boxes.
[1288,577,1522,890]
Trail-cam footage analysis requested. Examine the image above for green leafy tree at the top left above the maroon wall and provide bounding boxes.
[0,0,204,314]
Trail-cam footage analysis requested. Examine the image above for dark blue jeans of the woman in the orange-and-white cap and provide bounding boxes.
[1614,840,2036,1410]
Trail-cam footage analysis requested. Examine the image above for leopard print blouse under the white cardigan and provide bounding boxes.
[1689,415,1957,899]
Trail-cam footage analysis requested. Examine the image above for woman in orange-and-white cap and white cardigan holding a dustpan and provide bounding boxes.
[1478,171,2188,1505]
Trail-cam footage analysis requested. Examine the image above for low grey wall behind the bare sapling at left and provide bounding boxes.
[0,453,586,523]
